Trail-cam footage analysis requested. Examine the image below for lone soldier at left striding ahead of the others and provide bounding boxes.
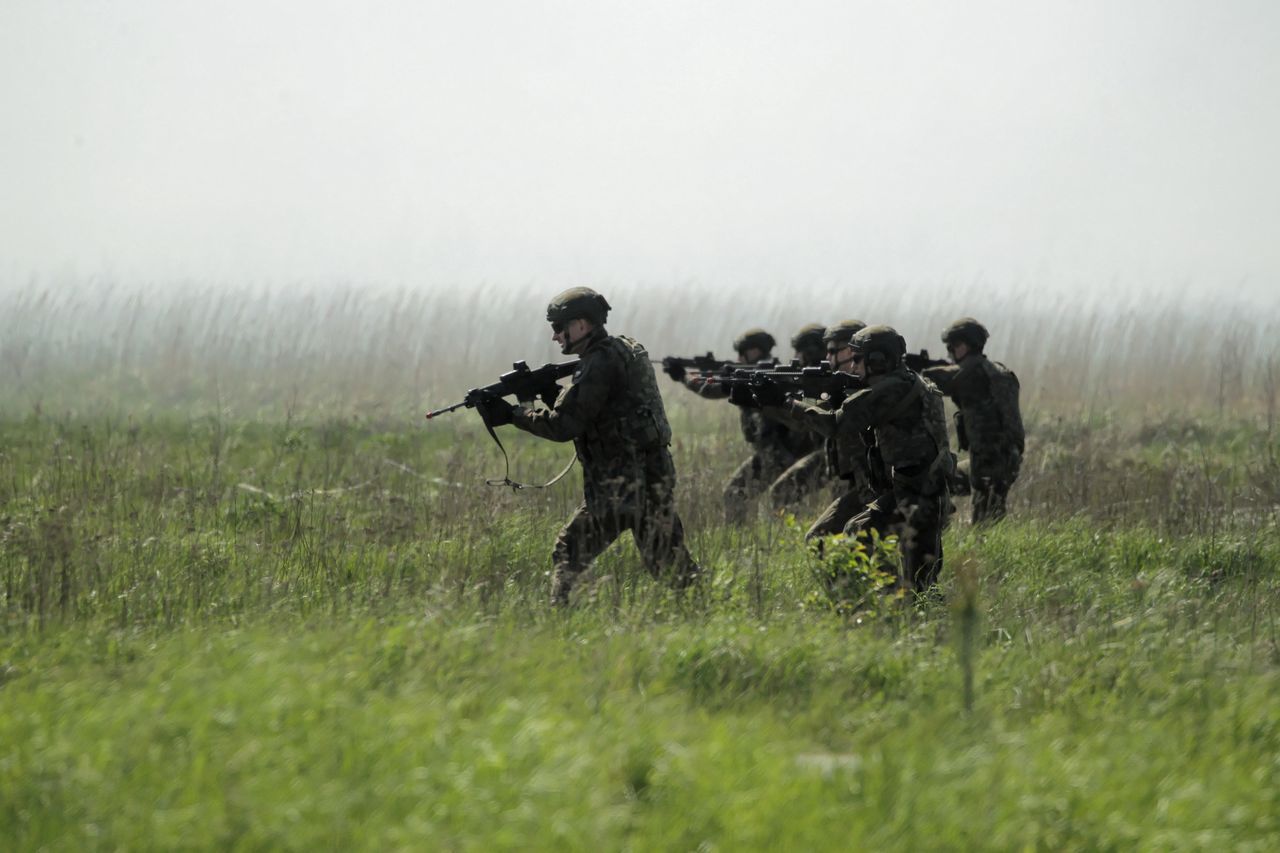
[481,287,699,606]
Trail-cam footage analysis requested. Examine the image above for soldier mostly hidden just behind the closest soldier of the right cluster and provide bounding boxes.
[764,320,874,527]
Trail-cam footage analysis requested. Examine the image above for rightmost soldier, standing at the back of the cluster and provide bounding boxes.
[922,316,1025,524]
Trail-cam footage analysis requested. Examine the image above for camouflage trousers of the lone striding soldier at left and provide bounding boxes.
[552,447,699,605]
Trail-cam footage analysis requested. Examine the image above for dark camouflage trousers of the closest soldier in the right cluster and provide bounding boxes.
[845,491,950,590]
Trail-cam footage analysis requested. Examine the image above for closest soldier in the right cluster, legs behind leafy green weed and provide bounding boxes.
[760,325,954,594]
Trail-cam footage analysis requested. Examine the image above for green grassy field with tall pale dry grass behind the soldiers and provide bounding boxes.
[0,285,1280,850]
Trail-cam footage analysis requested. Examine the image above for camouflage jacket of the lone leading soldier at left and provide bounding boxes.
[513,328,671,476]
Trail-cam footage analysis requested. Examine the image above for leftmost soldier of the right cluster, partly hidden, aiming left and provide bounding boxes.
[666,328,813,524]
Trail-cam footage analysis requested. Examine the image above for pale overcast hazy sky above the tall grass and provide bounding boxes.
[0,0,1280,295]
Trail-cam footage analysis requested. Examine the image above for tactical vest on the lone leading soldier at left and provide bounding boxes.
[579,336,671,461]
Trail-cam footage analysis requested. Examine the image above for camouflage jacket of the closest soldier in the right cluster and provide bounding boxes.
[790,368,955,494]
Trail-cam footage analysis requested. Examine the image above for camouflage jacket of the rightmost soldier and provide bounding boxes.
[922,352,1025,459]
